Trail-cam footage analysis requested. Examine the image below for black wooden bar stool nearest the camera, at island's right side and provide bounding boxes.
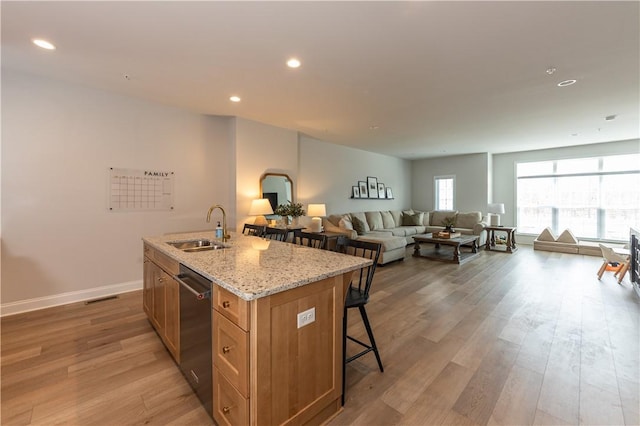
[336,237,384,405]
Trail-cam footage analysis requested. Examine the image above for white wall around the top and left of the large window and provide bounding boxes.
[493,139,640,226]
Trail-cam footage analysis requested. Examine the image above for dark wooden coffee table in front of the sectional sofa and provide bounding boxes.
[413,234,478,264]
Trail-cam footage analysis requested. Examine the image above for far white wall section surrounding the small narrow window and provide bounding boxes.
[411,153,490,214]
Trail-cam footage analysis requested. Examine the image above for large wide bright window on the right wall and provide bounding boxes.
[516,154,640,241]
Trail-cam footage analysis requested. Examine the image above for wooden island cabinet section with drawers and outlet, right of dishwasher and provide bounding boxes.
[212,276,348,425]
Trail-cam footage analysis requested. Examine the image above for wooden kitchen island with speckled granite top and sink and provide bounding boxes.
[143,232,371,425]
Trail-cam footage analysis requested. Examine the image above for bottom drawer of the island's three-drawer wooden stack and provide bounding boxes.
[213,368,249,426]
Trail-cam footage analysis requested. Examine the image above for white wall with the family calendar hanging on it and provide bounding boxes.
[0,70,232,314]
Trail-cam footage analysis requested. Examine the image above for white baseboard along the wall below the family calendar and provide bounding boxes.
[0,280,142,317]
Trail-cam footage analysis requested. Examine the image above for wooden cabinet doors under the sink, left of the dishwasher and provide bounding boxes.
[142,244,180,363]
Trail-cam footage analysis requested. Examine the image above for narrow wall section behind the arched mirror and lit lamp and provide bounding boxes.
[232,118,298,231]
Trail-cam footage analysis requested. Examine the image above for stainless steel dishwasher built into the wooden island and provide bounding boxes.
[175,264,213,418]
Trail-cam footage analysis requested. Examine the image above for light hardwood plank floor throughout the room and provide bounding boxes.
[0,246,640,426]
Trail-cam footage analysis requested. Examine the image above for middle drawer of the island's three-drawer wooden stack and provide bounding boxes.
[213,311,249,397]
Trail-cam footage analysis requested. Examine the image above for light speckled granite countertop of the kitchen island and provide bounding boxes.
[143,231,372,300]
